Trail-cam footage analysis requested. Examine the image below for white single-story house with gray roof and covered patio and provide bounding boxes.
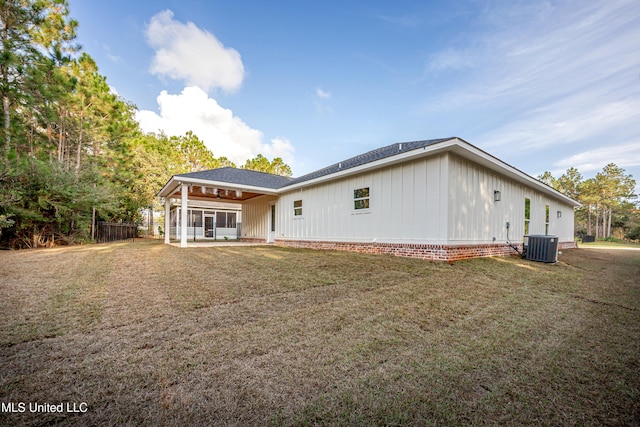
[159,138,579,261]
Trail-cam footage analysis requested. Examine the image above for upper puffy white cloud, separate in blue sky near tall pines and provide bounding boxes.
[146,10,244,92]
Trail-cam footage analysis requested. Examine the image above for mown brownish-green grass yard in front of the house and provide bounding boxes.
[0,240,640,426]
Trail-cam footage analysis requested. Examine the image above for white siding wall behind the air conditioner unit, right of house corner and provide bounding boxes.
[448,155,574,244]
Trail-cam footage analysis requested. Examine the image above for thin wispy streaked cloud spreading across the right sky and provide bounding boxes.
[422,0,640,181]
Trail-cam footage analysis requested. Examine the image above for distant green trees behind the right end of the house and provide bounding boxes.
[538,163,640,240]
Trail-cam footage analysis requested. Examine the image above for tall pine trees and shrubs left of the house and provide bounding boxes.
[0,0,291,248]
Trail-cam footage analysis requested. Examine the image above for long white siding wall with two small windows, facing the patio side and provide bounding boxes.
[276,154,449,243]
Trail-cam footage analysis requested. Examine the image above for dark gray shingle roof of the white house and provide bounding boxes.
[176,138,452,190]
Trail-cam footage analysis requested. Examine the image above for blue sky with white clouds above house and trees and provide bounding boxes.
[69,0,640,191]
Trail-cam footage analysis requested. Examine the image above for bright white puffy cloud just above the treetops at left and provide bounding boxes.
[136,86,295,166]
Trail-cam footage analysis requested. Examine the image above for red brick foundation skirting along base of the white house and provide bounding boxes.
[276,240,528,261]
